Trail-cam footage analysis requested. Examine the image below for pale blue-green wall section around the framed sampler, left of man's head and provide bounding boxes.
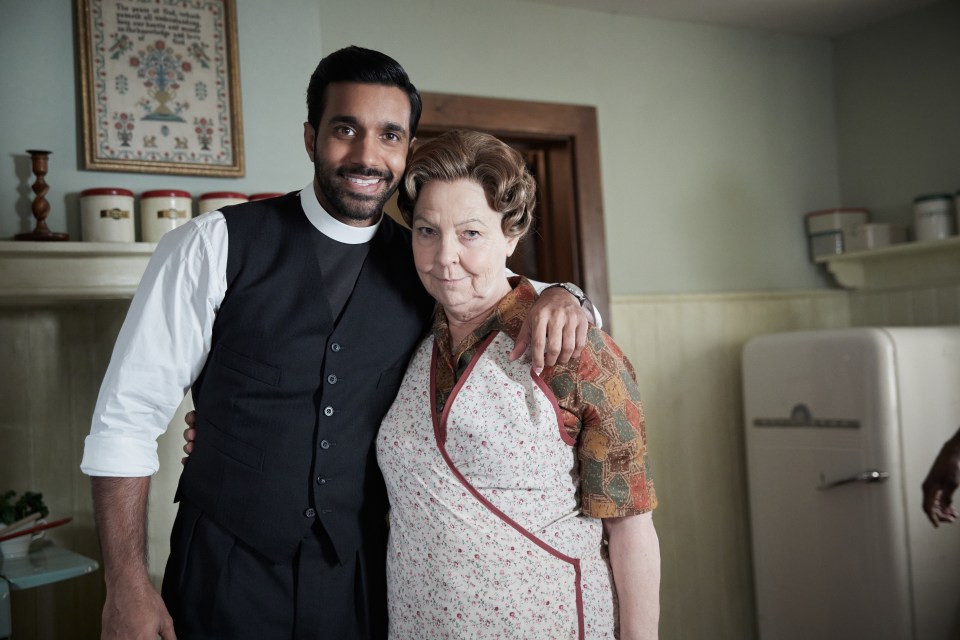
[0,0,323,240]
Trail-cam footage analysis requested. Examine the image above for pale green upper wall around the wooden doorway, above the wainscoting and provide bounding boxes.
[320,0,839,295]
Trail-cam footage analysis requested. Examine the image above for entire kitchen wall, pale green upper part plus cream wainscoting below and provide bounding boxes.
[0,0,960,640]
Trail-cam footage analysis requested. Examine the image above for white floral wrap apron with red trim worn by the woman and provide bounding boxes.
[377,333,616,639]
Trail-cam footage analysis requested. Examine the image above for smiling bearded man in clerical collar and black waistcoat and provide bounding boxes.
[81,47,586,640]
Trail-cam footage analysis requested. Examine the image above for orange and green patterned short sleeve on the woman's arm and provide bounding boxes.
[561,327,657,518]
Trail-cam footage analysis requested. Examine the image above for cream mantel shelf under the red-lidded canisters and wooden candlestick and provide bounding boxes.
[0,240,157,304]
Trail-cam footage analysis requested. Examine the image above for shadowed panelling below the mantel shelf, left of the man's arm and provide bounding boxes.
[0,301,127,640]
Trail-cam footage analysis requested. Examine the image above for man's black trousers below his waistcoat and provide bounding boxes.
[162,501,387,640]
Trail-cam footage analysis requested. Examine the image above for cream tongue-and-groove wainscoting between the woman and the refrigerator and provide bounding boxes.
[613,291,849,640]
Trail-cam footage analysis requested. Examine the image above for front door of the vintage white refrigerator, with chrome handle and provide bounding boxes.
[743,329,914,640]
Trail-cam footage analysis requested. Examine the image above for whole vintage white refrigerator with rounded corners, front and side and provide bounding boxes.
[743,327,960,640]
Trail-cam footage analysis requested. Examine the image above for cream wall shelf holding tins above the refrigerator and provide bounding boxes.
[816,236,960,291]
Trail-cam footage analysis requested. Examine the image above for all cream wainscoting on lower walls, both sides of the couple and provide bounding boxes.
[0,287,960,640]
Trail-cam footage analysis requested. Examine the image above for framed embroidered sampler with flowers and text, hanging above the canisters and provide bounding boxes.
[74,0,244,178]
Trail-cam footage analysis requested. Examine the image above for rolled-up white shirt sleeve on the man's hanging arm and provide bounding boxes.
[80,212,227,477]
